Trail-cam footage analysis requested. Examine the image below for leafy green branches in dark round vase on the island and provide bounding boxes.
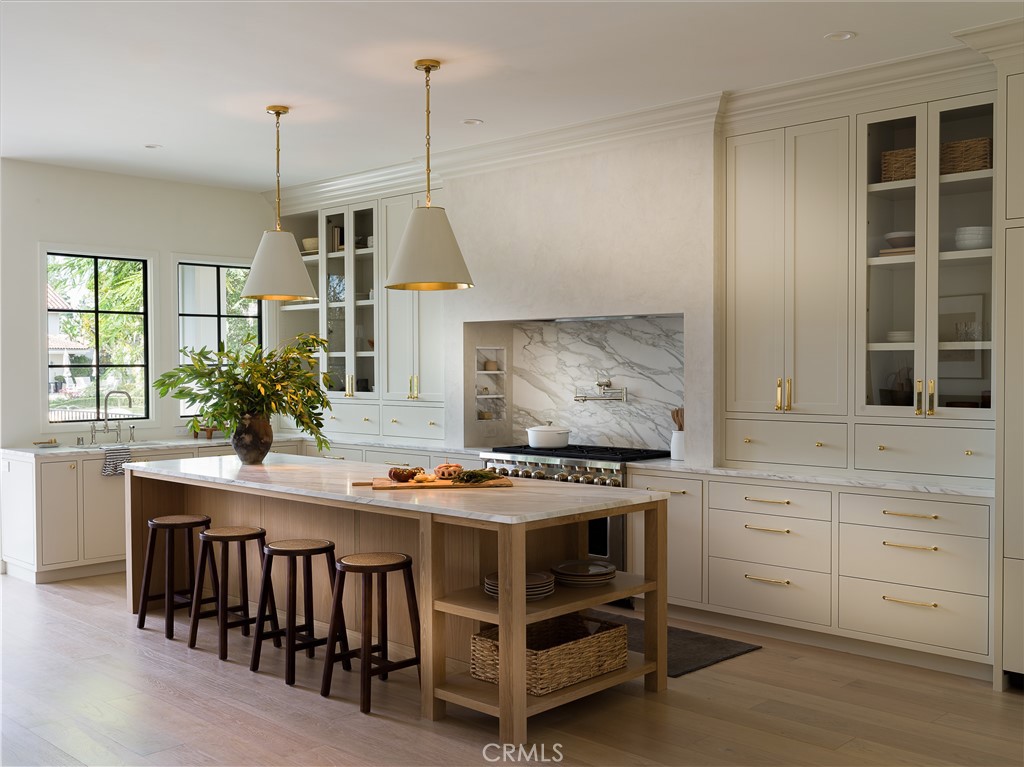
[154,333,331,464]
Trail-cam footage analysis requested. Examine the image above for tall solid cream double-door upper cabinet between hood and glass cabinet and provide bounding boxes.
[725,118,850,417]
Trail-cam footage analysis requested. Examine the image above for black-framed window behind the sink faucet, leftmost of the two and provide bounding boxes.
[46,253,150,423]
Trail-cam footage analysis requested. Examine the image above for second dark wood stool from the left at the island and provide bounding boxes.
[188,527,281,661]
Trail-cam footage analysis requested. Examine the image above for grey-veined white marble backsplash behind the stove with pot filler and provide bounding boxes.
[511,314,683,450]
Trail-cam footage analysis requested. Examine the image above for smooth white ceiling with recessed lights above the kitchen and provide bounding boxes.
[0,0,1024,190]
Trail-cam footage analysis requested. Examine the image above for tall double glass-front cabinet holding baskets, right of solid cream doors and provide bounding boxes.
[857,93,993,420]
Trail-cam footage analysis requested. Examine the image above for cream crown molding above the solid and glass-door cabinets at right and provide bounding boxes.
[722,47,995,134]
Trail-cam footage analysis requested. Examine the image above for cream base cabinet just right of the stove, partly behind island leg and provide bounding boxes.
[628,471,703,604]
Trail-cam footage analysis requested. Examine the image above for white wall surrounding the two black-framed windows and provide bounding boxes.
[0,160,273,446]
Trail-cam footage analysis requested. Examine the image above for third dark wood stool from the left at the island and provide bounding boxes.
[249,538,334,684]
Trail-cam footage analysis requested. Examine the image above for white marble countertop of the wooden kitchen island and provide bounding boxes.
[125,454,669,524]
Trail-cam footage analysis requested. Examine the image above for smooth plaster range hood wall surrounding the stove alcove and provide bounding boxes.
[444,130,715,465]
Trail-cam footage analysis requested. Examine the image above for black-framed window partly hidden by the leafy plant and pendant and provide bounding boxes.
[178,263,263,417]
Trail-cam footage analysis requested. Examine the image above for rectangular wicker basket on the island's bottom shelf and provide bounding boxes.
[469,612,627,695]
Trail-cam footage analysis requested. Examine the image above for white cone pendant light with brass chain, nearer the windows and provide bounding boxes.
[242,104,316,301]
